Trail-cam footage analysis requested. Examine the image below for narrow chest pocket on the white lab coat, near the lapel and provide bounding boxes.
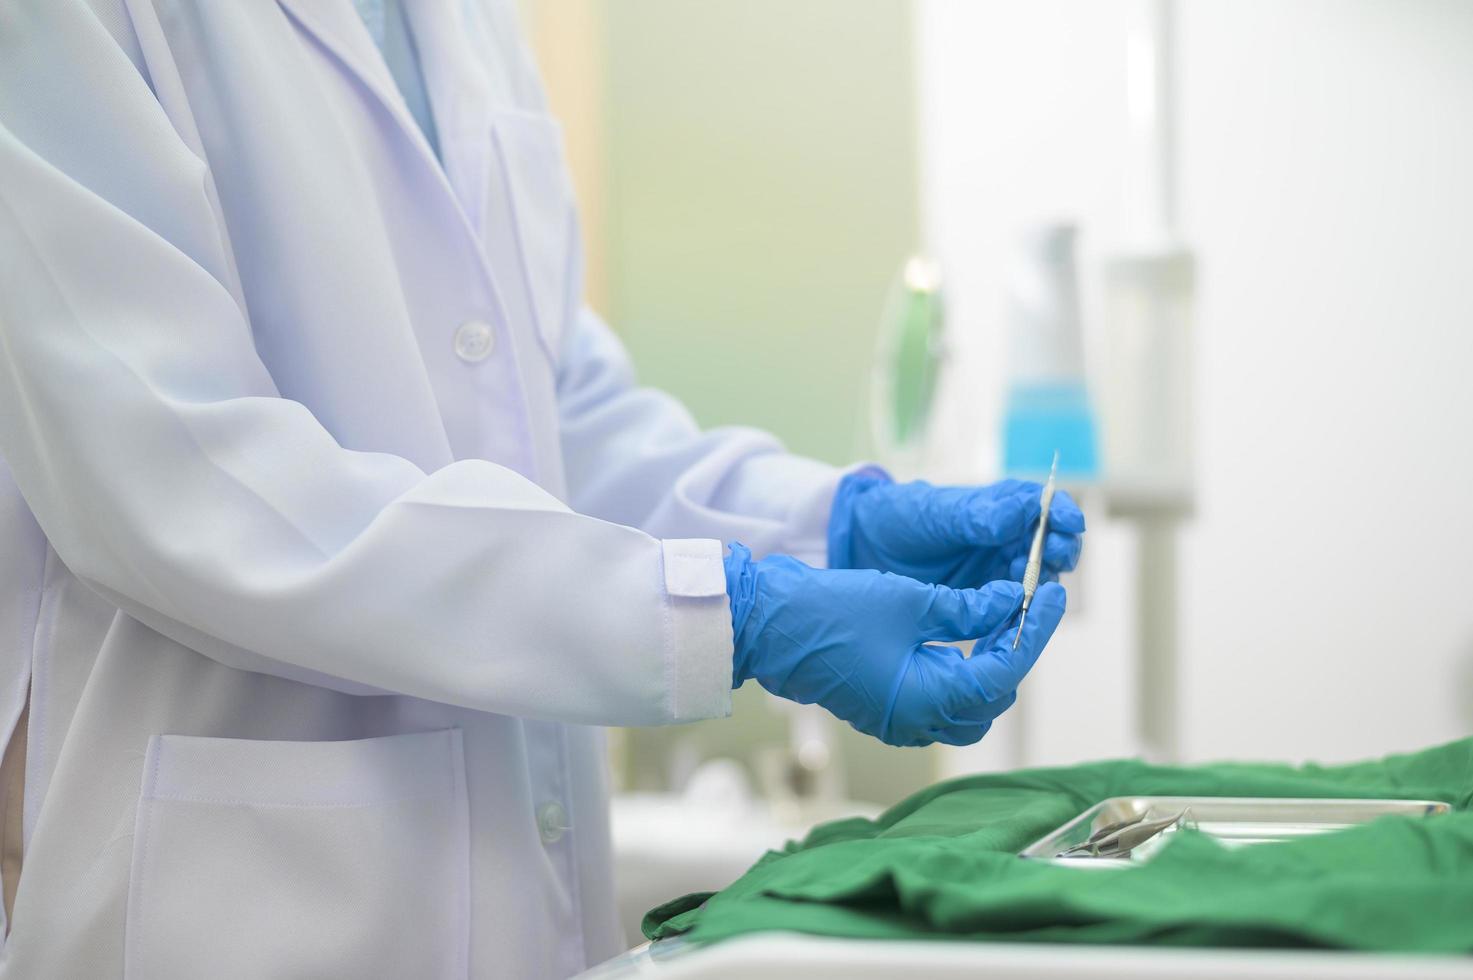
[491,112,582,365]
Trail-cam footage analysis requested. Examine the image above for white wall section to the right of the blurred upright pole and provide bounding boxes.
[1181,0,1473,759]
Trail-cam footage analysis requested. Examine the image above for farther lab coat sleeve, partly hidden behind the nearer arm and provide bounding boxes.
[558,307,844,567]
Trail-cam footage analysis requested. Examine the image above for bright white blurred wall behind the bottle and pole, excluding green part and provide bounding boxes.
[918,0,1473,768]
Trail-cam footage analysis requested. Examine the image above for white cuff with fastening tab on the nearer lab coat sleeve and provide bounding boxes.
[660,538,732,722]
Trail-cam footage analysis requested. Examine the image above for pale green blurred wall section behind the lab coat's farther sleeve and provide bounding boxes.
[604,0,918,463]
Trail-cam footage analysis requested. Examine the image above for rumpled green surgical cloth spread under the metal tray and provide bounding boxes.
[644,738,1473,952]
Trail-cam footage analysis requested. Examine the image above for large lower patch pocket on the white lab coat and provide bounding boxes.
[124,729,470,980]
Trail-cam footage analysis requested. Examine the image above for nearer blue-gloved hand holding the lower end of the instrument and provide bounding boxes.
[726,542,1064,746]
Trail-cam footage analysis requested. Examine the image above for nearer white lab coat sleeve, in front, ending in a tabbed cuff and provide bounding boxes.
[0,11,732,725]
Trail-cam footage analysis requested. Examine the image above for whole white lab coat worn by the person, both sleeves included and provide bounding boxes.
[0,0,838,980]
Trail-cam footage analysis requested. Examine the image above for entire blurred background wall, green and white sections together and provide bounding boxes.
[524,0,1473,803]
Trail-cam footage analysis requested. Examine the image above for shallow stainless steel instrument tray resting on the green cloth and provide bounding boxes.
[1018,796,1452,868]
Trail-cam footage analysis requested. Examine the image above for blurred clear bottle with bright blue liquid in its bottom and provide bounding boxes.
[1003,223,1099,480]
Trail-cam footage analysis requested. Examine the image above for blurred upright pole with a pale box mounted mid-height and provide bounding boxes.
[1103,0,1196,762]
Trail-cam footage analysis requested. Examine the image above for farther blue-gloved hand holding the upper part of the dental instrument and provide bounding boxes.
[828,470,1084,588]
